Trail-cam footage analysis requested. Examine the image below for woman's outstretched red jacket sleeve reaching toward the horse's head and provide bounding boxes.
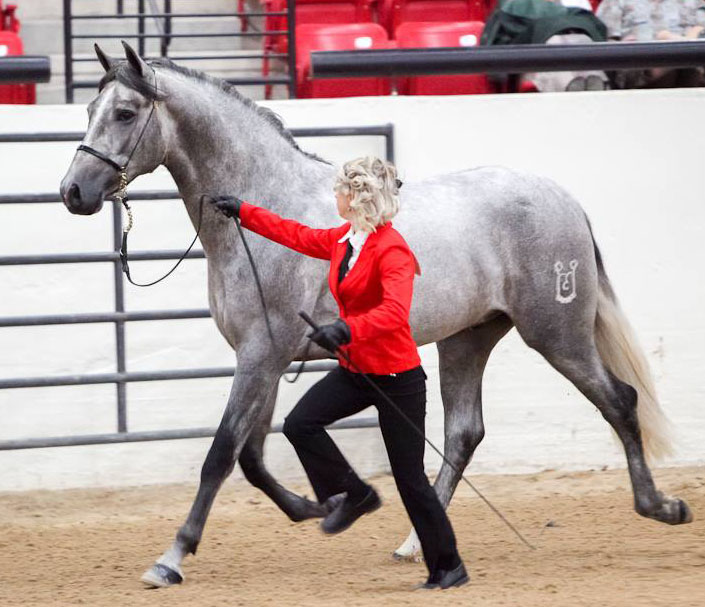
[239,201,345,260]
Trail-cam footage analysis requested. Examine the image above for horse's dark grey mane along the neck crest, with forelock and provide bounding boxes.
[98,58,330,164]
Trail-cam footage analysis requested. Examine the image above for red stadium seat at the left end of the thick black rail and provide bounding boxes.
[296,23,391,97]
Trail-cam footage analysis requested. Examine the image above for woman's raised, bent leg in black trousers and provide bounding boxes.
[284,367,372,503]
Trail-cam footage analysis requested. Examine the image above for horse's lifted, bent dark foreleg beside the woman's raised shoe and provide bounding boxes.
[238,387,328,522]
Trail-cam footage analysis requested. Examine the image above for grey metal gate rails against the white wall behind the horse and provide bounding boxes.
[0,124,394,451]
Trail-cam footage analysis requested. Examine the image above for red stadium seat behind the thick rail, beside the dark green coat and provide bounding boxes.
[396,21,494,95]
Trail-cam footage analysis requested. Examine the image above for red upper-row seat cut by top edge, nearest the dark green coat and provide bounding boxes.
[378,0,492,37]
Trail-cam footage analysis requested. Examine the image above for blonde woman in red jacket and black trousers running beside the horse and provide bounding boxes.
[209,157,469,588]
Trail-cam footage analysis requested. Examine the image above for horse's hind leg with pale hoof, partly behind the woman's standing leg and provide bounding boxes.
[394,314,512,560]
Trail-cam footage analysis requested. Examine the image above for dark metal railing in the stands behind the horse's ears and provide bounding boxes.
[63,0,296,103]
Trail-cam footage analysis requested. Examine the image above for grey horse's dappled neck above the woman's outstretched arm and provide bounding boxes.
[166,83,334,253]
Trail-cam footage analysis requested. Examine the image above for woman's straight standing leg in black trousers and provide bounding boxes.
[376,378,461,581]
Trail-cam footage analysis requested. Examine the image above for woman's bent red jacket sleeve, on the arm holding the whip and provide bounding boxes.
[345,246,415,342]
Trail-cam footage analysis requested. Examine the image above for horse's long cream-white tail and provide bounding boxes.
[595,276,672,461]
